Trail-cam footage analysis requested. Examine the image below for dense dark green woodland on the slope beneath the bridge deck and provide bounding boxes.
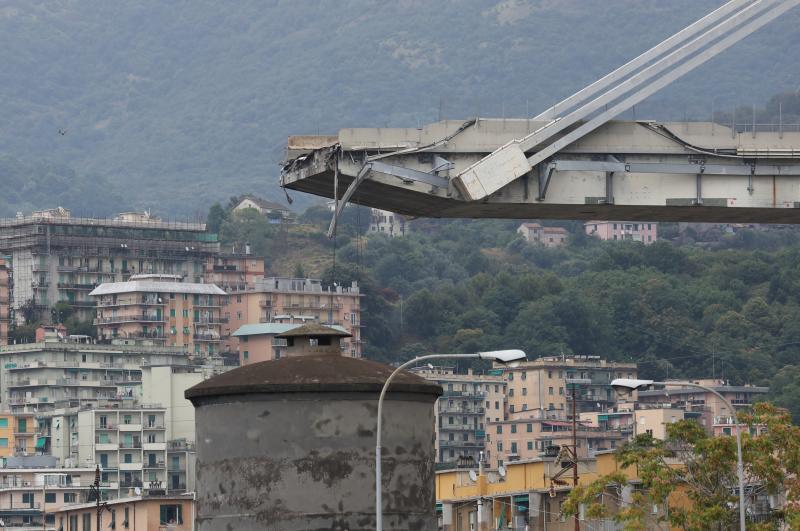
[212,207,800,419]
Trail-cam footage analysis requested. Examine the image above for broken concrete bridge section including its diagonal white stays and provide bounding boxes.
[281,0,800,231]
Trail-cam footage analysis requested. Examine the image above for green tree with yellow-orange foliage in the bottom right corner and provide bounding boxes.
[564,403,800,531]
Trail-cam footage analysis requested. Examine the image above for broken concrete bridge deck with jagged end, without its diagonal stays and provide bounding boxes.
[281,119,800,223]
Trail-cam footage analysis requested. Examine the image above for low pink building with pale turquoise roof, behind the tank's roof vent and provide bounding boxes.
[236,321,353,365]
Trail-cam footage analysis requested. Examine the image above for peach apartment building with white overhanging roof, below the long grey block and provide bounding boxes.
[89,275,228,356]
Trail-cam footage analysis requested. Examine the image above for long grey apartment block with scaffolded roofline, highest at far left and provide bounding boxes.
[0,208,219,320]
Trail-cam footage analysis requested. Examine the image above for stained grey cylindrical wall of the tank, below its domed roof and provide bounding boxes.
[196,393,436,531]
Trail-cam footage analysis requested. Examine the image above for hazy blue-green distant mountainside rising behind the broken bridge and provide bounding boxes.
[0,0,800,216]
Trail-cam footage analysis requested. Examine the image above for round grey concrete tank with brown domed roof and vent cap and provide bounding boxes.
[186,324,442,531]
